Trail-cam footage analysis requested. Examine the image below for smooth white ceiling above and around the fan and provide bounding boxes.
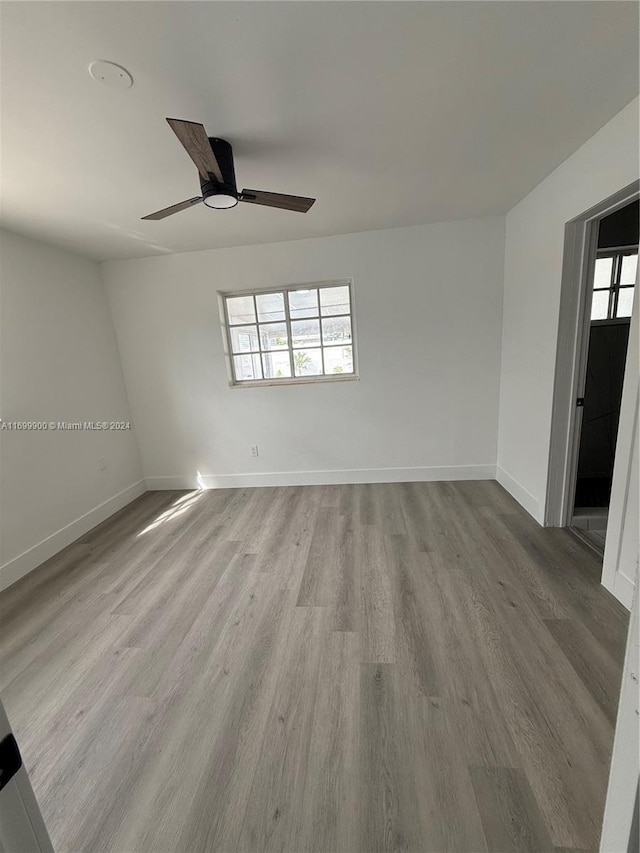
[1,2,638,259]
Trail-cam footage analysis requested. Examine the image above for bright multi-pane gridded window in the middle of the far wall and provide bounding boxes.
[220,280,356,385]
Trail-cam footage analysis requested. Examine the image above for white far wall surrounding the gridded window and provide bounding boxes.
[103,216,504,488]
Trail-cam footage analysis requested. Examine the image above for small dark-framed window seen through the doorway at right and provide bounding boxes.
[591,248,638,320]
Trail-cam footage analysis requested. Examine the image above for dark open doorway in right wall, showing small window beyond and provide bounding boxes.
[571,201,640,555]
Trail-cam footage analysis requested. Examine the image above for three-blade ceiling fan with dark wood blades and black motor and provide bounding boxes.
[142,118,315,219]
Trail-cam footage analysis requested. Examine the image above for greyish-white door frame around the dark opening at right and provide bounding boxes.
[544,181,640,527]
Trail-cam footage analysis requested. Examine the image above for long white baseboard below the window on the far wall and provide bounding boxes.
[146,465,496,491]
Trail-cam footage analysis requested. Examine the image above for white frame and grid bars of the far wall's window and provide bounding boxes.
[218,278,360,388]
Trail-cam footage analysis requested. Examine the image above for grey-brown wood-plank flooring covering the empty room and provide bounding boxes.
[0,482,627,853]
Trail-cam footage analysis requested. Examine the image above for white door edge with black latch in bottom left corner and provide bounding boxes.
[0,700,53,853]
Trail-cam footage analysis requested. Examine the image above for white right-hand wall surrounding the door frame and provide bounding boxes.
[498,93,640,523]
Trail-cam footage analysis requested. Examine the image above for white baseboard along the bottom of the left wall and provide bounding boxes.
[0,480,146,590]
